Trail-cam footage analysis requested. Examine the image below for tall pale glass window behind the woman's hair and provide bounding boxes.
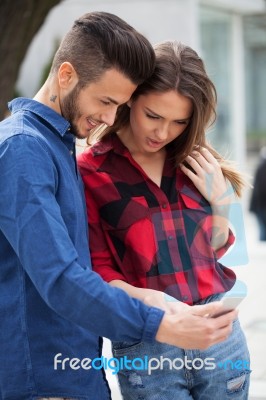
[200,7,233,155]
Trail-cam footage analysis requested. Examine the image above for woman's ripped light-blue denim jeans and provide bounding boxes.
[113,296,250,400]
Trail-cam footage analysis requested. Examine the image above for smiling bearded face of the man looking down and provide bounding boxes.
[60,69,137,139]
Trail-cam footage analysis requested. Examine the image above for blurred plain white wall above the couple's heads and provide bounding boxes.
[18,0,199,97]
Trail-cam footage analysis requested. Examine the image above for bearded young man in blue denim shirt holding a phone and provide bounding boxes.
[0,12,236,400]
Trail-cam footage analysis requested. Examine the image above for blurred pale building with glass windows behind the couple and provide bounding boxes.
[18,0,266,167]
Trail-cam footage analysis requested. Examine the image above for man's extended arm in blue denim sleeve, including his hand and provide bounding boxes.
[0,135,234,348]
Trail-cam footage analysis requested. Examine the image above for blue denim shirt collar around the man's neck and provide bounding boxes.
[8,97,70,136]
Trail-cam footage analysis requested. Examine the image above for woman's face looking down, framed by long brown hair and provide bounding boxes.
[129,90,193,153]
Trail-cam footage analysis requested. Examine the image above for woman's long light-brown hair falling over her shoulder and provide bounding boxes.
[93,41,245,196]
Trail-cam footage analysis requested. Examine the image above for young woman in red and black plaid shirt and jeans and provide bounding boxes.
[79,41,250,400]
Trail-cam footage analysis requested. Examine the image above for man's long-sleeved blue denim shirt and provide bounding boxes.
[0,98,163,400]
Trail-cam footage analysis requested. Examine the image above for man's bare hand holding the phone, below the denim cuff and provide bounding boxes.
[156,302,237,350]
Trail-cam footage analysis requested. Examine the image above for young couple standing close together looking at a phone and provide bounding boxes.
[0,12,249,400]
